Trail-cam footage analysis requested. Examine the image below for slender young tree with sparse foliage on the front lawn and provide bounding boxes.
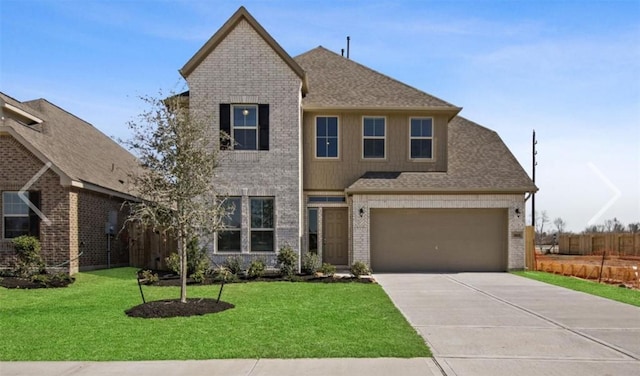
[122,95,227,303]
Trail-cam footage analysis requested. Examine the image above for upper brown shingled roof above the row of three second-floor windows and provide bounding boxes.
[294,46,461,118]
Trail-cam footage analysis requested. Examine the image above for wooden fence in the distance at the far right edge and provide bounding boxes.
[558,233,640,256]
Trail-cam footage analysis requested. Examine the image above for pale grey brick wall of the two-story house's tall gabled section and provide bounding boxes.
[187,21,302,261]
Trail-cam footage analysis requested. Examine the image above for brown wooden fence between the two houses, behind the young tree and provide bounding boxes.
[129,224,178,270]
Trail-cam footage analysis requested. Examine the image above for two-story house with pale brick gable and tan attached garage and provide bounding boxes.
[180,7,536,272]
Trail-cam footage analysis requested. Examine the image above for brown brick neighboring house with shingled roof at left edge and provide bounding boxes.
[0,93,137,273]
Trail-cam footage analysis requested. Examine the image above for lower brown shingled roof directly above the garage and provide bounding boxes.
[346,116,538,193]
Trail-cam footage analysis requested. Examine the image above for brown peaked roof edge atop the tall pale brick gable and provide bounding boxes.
[180,6,307,95]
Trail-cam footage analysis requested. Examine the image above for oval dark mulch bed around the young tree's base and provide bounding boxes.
[125,299,235,319]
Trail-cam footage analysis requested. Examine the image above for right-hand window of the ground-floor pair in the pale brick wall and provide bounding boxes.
[250,197,274,252]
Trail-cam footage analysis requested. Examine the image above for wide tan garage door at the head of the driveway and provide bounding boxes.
[370,209,507,272]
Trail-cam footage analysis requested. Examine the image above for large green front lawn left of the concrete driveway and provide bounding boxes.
[0,268,431,361]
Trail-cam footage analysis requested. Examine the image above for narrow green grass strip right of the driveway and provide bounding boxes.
[513,272,640,307]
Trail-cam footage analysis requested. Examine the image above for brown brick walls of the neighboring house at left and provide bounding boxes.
[0,135,128,274]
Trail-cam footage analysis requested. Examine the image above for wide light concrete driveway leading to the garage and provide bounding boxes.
[376,273,640,376]
